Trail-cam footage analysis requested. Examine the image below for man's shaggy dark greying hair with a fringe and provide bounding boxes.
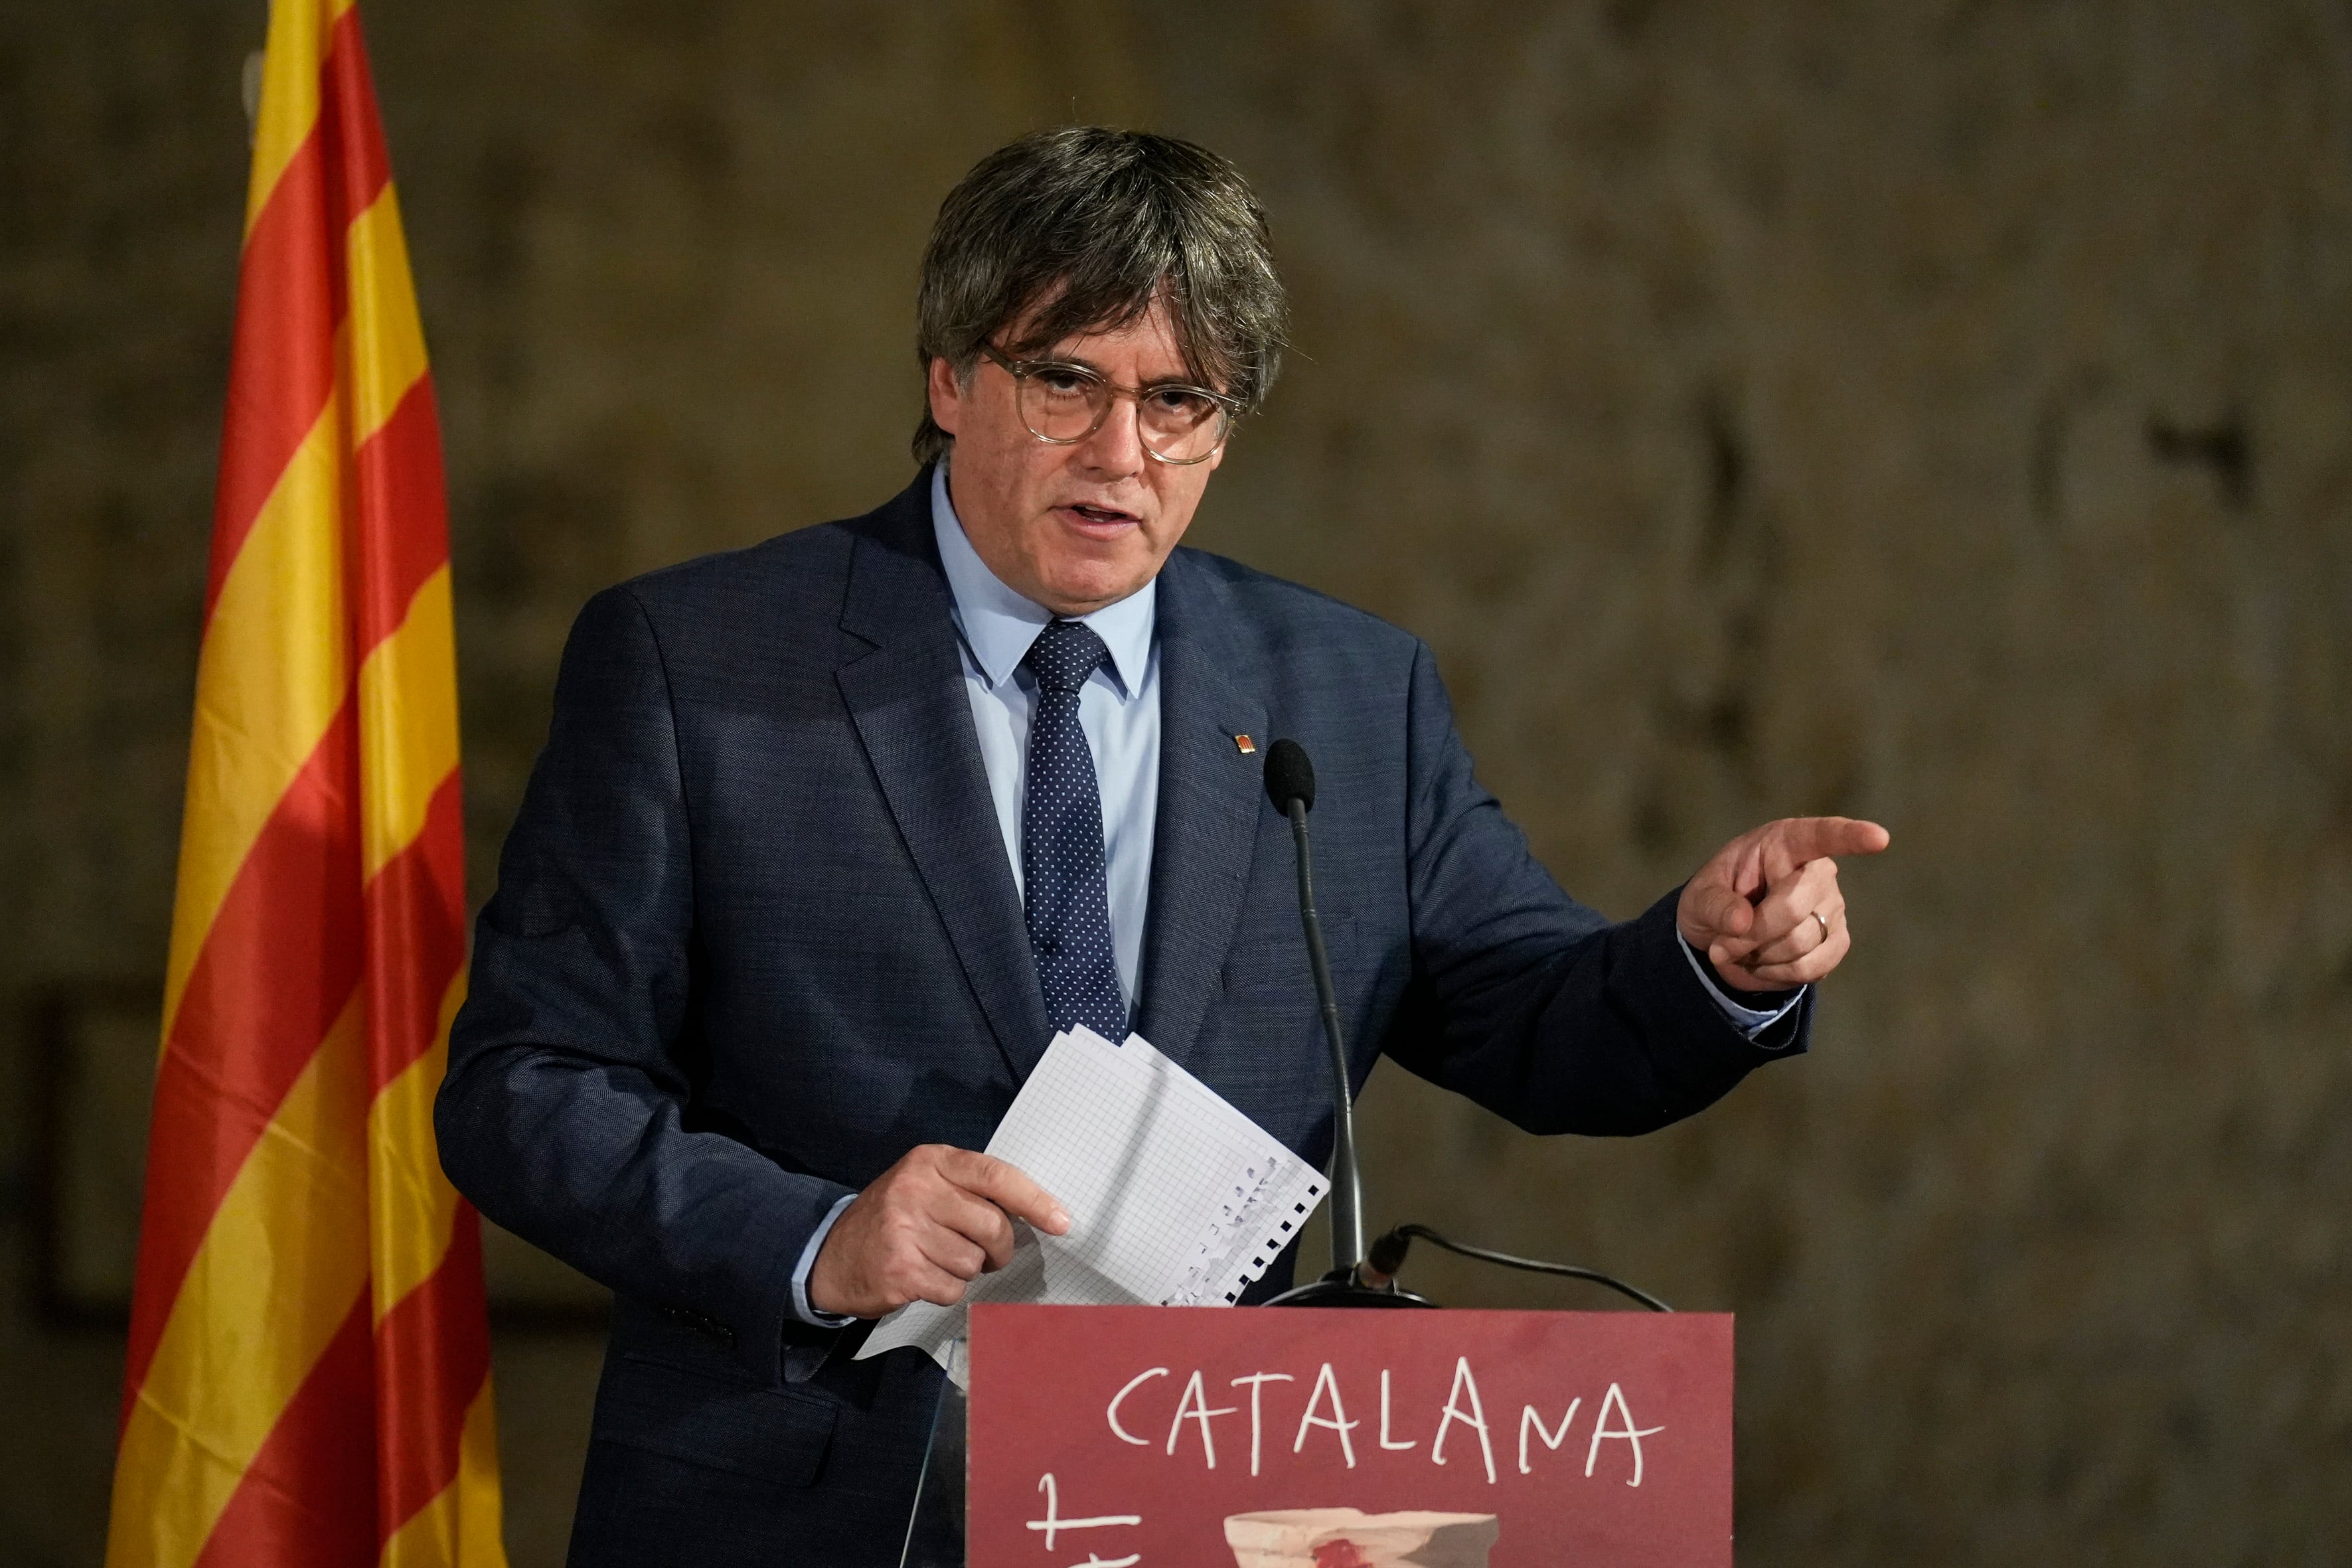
[915,125,1289,463]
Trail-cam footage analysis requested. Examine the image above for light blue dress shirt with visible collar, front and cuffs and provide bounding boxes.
[793,463,1804,1328]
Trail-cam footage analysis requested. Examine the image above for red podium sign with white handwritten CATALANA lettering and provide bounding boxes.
[967,1307,1731,1568]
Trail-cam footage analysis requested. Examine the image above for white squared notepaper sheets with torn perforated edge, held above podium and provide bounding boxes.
[858,1028,1324,1382]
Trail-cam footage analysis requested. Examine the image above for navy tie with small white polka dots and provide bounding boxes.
[1021,621,1127,1042]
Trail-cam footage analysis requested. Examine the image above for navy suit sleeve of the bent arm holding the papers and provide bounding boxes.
[435,588,846,1382]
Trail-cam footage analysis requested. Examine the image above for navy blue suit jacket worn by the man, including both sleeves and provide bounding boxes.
[437,477,1806,1565]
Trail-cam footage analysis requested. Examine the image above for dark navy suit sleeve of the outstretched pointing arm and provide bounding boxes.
[1385,647,1814,1133]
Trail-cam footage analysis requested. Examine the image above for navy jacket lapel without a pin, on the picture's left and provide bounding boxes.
[835,484,1049,1084]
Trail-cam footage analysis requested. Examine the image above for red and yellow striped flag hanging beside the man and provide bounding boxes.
[106,0,503,1568]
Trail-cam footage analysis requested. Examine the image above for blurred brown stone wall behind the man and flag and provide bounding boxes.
[0,0,2352,1568]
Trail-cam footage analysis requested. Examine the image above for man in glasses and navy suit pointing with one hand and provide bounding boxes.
[437,129,1886,1565]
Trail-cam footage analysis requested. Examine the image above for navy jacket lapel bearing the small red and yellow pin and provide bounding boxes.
[1134,552,1268,1060]
